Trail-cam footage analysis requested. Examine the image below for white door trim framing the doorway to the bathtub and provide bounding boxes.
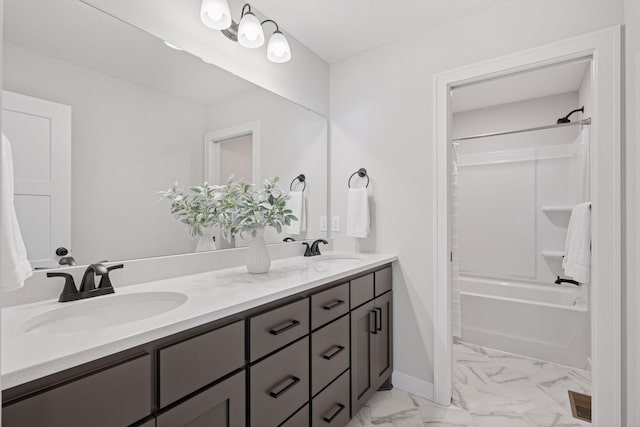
[433,26,622,427]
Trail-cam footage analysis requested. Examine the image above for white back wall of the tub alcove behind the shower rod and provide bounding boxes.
[452,92,588,286]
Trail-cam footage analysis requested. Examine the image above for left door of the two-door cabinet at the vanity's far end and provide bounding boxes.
[351,301,378,416]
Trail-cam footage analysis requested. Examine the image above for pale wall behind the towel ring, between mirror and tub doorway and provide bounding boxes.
[330,0,623,394]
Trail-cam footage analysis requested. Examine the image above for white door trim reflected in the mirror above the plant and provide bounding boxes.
[203,120,262,184]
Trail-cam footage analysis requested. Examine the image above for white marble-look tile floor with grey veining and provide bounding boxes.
[348,342,591,427]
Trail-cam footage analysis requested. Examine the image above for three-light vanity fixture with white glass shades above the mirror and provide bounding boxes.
[200,0,291,64]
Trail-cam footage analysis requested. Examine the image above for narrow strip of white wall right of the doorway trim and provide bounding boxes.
[622,0,640,427]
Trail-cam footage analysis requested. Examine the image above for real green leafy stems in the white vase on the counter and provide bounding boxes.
[219,176,298,244]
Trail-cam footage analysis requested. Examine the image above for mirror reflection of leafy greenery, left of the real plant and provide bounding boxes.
[159,182,224,237]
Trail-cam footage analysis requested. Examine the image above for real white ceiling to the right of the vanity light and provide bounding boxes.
[248,0,511,62]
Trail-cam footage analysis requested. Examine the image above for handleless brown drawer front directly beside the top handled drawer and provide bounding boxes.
[158,321,244,407]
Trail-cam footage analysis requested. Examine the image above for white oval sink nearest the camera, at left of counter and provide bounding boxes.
[21,292,187,334]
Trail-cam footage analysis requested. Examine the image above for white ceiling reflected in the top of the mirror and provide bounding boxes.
[3,0,256,106]
